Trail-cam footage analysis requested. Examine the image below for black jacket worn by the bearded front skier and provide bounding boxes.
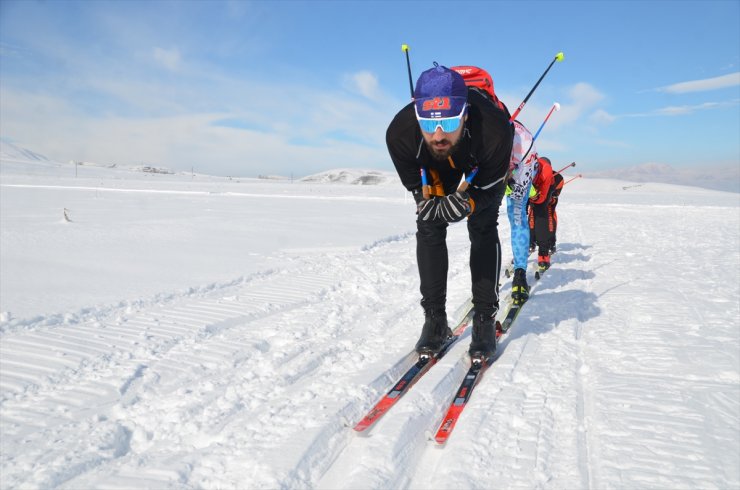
[385,88,514,213]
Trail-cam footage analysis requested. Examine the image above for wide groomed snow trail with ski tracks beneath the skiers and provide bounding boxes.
[0,175,740,489]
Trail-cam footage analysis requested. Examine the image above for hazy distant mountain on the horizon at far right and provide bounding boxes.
[587,163,740,193]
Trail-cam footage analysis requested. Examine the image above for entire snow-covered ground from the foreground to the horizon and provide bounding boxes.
[0,151,740,489]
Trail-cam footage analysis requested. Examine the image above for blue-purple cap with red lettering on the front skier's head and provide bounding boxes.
[414,62,468,119]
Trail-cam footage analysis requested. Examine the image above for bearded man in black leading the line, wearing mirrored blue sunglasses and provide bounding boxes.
[386,63,513,358]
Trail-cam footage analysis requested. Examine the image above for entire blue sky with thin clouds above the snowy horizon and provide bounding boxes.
[0,0,740,176]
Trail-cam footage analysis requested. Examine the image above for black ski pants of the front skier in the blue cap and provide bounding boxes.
[416,184,505,314]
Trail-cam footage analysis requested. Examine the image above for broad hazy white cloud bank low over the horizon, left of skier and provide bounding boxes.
[0,81,400,176]
